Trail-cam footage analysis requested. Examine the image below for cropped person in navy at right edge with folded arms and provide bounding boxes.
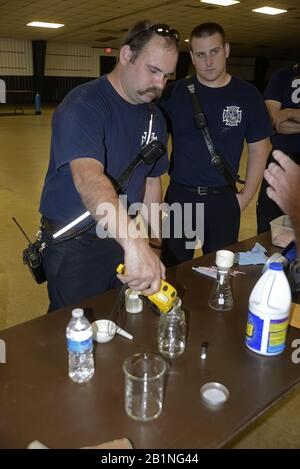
[256,64,300,233]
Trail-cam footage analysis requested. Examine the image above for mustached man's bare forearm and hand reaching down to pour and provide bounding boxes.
[70,157,165,295]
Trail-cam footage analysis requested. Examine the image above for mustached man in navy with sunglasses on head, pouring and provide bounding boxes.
[40,21,179,311]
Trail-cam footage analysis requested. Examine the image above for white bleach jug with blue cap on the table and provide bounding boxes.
[246,262,292,355]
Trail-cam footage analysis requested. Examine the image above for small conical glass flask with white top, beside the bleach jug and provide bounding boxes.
[208,250,234,311]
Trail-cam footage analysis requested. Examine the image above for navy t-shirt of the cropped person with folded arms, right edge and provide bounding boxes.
[264,70,300,156]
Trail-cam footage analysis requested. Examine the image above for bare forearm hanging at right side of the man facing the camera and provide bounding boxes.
[236,138,271,211]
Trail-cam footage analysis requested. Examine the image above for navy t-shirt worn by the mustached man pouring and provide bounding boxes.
[40,76,168,224]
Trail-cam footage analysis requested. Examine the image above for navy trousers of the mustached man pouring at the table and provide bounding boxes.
[43,233,124,312]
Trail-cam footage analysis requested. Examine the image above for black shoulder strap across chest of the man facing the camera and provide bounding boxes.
[187,77,245,187]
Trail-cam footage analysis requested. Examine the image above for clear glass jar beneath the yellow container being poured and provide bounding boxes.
[158,298,186,358]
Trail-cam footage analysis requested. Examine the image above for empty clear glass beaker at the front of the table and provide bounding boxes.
[123,353,166,421]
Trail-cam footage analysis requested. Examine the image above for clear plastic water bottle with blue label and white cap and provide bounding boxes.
[66,308,95,383]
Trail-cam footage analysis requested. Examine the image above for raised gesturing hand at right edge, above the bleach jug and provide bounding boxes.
[264,150,300,255]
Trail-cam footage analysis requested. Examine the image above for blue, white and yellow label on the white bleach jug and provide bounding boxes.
[246,311,288,355]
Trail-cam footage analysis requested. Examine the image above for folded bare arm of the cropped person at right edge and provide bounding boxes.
[265,99,300,135]
